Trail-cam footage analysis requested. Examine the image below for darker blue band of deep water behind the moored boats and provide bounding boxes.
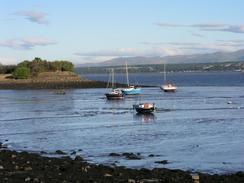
[84,72,244,86]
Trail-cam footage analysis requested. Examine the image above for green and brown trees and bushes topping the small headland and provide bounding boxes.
[0,57,74,79]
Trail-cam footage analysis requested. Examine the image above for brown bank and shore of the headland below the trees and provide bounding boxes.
[0,72,130,90]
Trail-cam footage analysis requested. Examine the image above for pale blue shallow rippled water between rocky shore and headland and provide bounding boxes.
[0,73,244,174]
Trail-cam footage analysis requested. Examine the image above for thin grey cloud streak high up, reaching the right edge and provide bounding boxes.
[155,23,244,33]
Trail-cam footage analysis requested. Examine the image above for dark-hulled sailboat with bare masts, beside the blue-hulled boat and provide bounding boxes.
[105,69,124,100]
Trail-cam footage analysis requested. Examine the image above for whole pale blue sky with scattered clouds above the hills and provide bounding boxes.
[0,0,244,64]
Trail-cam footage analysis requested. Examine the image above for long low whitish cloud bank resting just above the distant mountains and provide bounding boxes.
[74,40,244,63]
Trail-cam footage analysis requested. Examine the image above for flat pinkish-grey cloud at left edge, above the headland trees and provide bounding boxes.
[0,37,57,50]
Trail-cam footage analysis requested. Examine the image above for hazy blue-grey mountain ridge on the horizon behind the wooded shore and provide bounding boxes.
[77,50,244,67]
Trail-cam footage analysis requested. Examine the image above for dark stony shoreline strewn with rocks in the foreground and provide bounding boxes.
[0,147,244,183]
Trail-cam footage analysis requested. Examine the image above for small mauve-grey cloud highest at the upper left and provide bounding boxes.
[14,11,49,25]
